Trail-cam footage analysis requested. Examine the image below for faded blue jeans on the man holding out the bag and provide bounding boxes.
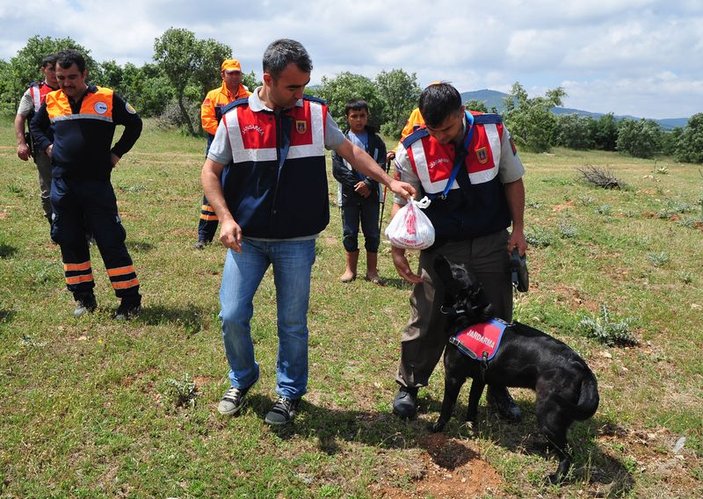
[220,239,315,399]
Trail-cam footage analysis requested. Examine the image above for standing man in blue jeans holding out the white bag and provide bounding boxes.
[201,39,415,425]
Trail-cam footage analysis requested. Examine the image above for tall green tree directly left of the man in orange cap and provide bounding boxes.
[154,28,232,135]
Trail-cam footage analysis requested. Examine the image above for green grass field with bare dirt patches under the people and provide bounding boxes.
[0,121,703,498]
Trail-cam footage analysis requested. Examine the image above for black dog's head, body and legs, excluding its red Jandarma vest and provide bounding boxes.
[432,257,599,483]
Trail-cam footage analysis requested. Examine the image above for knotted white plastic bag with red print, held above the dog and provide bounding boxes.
[386,196,434,249]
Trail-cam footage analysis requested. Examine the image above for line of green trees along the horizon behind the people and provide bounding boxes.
[0,28,703,163]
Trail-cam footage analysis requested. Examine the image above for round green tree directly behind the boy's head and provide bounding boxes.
[318,71,384,128]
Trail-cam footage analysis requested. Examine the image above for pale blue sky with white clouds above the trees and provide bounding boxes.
[0,0,703,119]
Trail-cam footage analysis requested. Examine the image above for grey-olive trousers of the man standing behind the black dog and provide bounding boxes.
[396,230,513,388]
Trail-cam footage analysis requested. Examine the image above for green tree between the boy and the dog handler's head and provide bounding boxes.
[376,69,422,137]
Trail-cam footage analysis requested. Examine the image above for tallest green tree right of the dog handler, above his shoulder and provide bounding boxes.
[504,82,566,152]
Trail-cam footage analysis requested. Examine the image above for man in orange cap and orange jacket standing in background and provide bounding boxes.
[194,59,251,249]
